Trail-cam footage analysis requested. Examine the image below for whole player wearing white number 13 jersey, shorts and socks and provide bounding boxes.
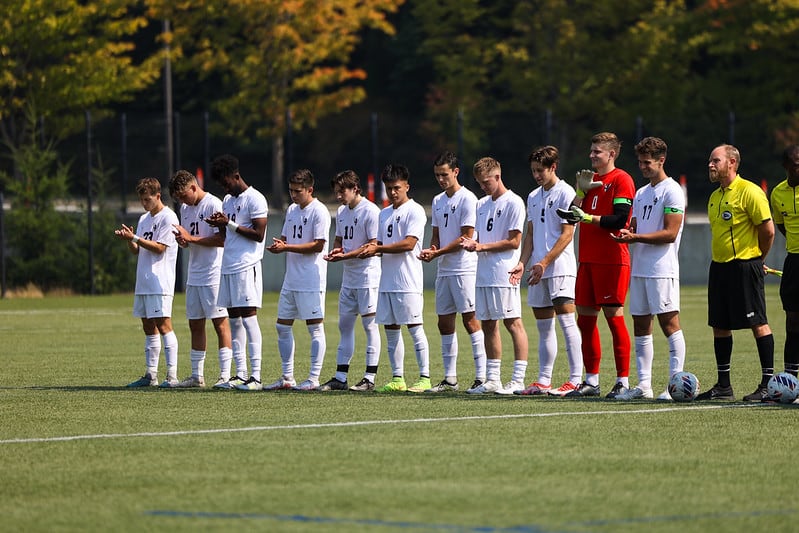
[264,169,330,391]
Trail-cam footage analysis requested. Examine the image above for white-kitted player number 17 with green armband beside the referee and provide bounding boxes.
[614,137,685,400]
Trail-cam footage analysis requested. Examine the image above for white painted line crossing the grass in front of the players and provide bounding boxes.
[0,404,757,445]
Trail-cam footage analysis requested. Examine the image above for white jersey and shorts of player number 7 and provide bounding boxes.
[432,187,477,277]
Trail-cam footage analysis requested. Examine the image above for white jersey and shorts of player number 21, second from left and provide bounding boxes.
[180,192,222,287]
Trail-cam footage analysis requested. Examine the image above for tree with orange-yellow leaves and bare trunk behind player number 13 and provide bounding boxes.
[148,0,404,203]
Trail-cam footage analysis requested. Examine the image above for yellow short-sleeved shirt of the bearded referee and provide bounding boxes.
[707,175,771,263]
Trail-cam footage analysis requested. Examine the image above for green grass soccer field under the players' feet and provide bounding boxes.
[0,285,799,532]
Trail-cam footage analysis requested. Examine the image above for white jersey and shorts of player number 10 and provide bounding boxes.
[336,198,380,289]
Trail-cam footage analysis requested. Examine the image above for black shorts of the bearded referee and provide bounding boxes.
[707,258,768,330]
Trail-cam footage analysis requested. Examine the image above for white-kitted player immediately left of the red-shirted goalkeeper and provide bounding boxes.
[510,146,583,396]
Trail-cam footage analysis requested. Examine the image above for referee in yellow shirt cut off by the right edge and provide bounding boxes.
[771,144,799,376]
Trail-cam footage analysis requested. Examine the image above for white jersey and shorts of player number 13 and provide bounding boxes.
[281,198,330,292]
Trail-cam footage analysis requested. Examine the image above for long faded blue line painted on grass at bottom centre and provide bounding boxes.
[144,510,558,533]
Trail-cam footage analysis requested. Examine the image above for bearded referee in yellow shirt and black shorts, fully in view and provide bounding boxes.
[696,144,774,401]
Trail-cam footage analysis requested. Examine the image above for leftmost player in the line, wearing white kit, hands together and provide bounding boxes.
[114,178,178,387]
